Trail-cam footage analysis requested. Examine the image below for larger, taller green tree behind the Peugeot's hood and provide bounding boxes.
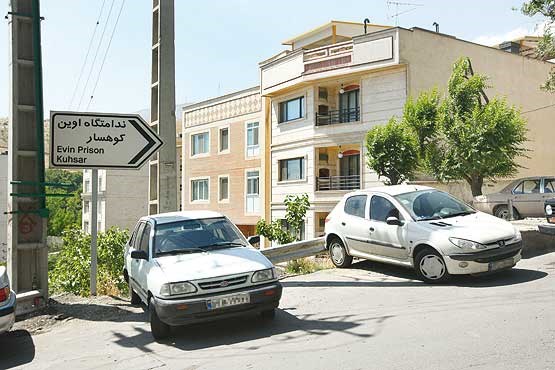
[424,58,527,196]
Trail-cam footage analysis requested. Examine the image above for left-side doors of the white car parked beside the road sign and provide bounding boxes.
[130,222,152,302]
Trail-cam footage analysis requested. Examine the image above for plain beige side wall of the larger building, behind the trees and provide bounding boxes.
[399,29,555,179]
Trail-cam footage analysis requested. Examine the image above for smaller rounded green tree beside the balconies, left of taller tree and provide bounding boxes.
[366,118,419,185]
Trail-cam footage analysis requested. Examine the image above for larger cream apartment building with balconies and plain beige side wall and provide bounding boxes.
[260,21,555,238]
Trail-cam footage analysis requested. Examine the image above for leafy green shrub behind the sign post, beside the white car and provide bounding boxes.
[50,228,129,296]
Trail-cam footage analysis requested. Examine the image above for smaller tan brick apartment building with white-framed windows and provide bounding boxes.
[181,86,265,235]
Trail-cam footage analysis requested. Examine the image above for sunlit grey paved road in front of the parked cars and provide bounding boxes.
[0,253,555,370]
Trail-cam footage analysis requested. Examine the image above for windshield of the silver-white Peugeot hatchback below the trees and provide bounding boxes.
[395,190,476,221]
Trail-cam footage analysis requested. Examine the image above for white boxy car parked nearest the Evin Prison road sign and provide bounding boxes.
[124,211,282,339]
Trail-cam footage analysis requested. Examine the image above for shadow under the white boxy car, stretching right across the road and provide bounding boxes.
[114,309,393,352]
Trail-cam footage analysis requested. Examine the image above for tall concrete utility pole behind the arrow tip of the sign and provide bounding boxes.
[149,0,178,214]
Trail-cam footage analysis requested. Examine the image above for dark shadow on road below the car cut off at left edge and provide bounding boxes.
[0,330,35,369]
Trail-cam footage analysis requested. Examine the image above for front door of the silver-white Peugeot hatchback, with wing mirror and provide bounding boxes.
[369,195,408,260]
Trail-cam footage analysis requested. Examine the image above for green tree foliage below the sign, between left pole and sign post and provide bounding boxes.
[46,169,83,236]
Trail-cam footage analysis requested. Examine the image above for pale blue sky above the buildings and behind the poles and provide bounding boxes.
[0,0,543,117]
